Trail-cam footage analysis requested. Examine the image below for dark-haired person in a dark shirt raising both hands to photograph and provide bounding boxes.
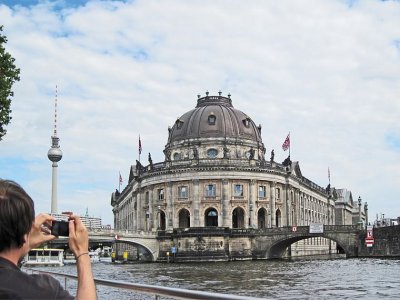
[0,179,97,300]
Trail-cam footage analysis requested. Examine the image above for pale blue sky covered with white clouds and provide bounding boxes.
[0,0,400,224]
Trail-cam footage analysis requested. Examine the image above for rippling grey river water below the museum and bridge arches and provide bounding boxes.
[32,258,400,299]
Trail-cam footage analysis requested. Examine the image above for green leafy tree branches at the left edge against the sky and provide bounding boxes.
[0,26,20,141]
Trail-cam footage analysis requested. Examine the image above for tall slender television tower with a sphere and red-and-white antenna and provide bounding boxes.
[47,86,62,214]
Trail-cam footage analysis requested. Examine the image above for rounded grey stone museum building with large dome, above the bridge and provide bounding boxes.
[111,92,365,258]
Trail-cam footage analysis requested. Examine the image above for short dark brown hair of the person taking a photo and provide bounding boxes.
[0,179,35,252]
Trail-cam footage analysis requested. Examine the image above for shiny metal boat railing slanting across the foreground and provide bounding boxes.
[26,268,262,300]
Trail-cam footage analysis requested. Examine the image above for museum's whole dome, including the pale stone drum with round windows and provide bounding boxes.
[164,92,265,160]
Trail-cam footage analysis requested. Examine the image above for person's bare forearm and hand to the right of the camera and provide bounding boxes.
[69,215,97,300]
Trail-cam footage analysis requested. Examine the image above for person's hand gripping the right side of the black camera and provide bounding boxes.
[68,215,89,257]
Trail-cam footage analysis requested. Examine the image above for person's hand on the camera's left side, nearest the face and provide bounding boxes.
[29,214,55,249]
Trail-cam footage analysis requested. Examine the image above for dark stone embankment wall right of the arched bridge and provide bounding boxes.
[358,225,400,257]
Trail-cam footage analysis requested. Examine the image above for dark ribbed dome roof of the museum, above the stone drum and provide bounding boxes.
[168,92,262,143]
